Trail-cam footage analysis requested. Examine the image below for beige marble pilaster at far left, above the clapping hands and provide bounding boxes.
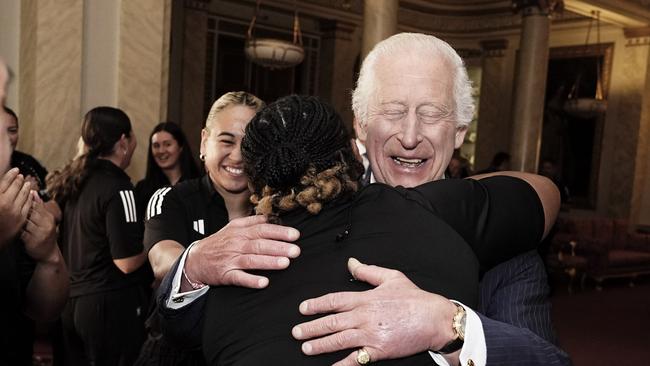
[16,0,84,170]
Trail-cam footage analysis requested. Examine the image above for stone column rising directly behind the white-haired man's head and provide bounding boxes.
[361,0,399,60]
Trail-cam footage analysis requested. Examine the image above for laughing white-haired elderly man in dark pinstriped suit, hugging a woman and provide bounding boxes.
[156,34,570,366]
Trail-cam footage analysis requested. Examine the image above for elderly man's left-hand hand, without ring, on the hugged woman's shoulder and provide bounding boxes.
[181,216,300,291]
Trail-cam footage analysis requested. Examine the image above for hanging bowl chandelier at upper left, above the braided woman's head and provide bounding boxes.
[244,0,305,69]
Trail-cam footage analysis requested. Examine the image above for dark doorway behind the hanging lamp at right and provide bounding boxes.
[540,45,612,208]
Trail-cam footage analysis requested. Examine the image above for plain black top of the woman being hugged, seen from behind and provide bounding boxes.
[203,177,544,365]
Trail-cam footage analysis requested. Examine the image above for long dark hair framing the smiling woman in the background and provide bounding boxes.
[145,122,199,186]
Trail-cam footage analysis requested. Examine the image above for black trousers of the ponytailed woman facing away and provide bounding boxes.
[61,287,148,366]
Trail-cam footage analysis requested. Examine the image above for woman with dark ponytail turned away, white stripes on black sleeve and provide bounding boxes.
[48,107,148,365]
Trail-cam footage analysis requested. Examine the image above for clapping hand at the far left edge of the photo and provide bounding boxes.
[0,168,32,246]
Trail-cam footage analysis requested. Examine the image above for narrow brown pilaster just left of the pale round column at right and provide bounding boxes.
[474,39,512,170]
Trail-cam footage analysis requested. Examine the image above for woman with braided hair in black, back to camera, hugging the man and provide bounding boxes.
[202,96,552,365]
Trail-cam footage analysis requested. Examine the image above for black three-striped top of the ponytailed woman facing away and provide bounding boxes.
[60,159,146,297]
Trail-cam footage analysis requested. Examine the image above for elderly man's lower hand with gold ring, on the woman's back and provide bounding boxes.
[292,258,456,366]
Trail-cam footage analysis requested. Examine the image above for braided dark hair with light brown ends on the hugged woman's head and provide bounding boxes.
[241,95,363,219]
